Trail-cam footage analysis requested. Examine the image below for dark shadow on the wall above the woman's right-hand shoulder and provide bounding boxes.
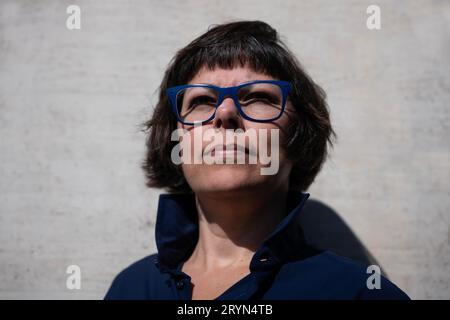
[298,199,386,275]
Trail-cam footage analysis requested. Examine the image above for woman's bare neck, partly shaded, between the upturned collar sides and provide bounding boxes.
[190,188,288,270]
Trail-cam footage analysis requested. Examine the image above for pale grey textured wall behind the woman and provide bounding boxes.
[0,0,450,299]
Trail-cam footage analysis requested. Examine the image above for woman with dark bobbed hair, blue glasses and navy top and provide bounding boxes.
[105,21,408,299]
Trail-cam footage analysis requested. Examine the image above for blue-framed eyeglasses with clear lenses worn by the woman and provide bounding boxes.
[166,80,292,125]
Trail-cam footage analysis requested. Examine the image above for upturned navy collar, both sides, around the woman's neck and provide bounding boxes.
[155,191,311,271]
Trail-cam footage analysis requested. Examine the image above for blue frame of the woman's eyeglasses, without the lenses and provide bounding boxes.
[166,80,292,126]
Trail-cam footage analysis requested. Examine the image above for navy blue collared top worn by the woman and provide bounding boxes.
[105,192,409,300]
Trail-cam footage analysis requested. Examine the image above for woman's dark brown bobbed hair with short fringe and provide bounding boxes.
[142,21,336,192]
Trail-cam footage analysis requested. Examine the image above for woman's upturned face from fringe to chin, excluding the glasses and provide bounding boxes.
[178,67,295,194]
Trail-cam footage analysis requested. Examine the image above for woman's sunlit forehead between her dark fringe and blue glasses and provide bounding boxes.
[188,66,277,87]
